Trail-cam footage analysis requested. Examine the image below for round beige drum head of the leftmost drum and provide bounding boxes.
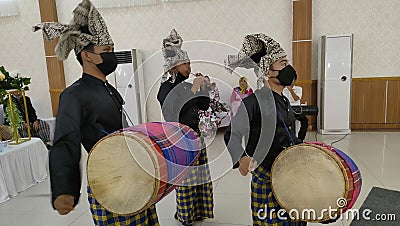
[87,133,160,215]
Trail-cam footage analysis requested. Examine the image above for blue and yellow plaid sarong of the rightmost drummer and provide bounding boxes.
[251,166,307,226]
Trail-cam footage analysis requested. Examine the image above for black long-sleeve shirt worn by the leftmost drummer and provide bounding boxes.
[49,74,123,205]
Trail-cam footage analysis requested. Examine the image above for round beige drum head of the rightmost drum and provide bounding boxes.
[271,144,347,222]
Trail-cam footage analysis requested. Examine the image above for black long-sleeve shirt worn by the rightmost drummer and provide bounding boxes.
[224,87,299,169]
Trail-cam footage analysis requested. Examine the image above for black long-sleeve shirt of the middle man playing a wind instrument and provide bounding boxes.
[157,76,210,132]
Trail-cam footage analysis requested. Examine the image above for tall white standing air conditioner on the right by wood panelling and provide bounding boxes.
[317,34,353,134]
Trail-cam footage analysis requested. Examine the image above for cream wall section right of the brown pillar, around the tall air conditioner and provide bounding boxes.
[312,0,400,79]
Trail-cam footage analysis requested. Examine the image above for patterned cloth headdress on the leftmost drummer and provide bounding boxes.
[33,0,114,60]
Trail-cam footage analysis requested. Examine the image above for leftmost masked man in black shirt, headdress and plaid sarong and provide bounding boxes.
[36,0,159,226]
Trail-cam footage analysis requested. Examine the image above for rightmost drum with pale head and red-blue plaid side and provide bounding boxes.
[271,142,362,222]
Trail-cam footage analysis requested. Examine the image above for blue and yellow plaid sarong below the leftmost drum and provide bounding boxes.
[87,186,160,226]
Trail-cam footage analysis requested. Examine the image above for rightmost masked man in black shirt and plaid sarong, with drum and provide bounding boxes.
[224,34,306,225]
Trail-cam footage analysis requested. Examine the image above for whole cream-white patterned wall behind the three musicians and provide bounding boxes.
[0,0,400,120]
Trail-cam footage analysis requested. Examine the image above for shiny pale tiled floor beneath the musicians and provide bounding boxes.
[0,132,400,226]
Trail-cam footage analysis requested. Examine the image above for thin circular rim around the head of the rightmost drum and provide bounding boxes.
[271,143,349,223]
